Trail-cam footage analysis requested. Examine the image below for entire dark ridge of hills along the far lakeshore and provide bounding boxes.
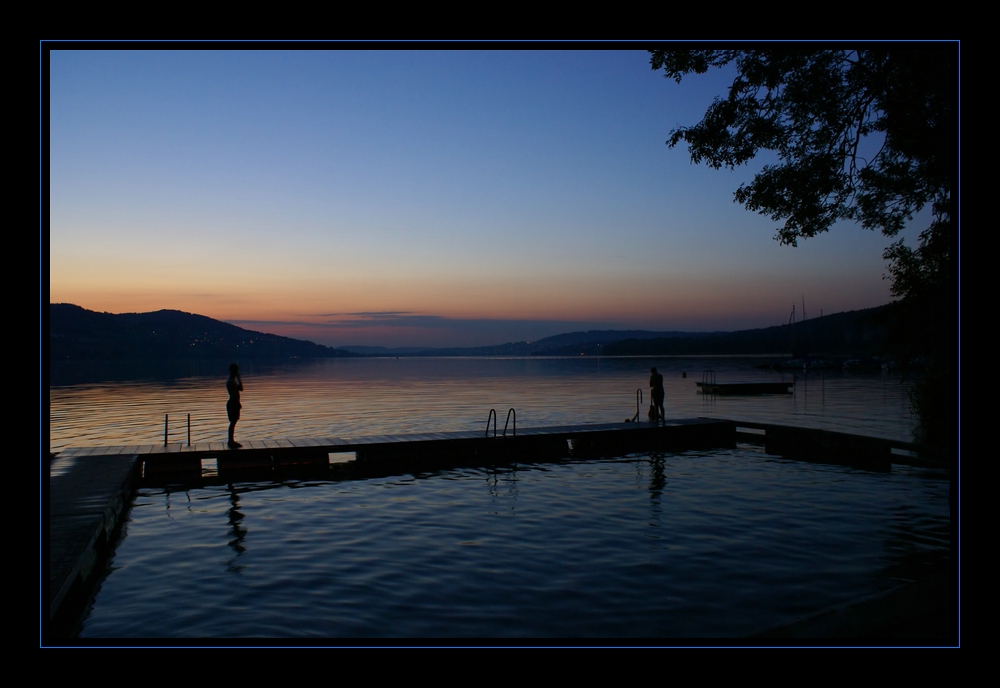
[49,304,891,361]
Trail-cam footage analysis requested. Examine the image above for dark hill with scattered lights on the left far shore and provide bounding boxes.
[49,303,358,361]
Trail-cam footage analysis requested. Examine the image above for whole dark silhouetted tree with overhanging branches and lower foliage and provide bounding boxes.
[650,45,958,441]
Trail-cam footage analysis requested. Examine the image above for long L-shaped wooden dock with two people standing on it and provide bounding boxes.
[43,418,947,620]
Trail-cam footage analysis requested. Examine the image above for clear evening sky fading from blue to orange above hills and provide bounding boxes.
[48,49,929,346]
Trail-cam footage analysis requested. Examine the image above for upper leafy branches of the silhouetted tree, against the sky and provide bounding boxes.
[650,46,957,246]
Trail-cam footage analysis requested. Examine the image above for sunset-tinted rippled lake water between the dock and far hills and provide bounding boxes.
[49,358,914,451]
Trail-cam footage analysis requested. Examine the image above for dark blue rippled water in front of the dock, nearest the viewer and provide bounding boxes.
[64,445,950,639]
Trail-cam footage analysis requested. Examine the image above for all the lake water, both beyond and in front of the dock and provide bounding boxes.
[51,359,949,638]
